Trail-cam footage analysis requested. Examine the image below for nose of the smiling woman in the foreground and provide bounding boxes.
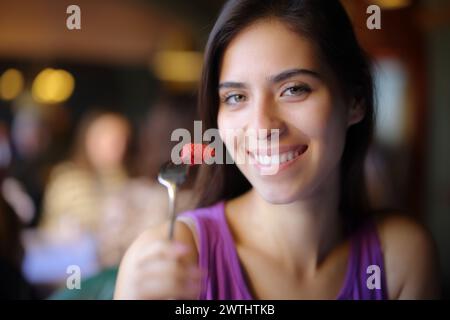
[247,97,286,140]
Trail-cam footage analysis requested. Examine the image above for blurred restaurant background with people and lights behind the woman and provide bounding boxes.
[0,0,450,299]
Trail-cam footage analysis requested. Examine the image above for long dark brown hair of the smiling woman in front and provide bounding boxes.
[197,0,374,227]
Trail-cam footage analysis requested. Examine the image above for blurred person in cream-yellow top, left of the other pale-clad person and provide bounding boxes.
[40,111,130,237]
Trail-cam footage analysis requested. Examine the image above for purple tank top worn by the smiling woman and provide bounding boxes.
[180,201,387,300]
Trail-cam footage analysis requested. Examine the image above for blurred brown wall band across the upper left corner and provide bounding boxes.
[0,0,191,65]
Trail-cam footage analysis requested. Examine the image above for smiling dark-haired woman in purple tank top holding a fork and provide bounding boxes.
[115,0,438,299]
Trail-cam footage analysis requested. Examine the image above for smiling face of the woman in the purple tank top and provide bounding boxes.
[218,20,363,204]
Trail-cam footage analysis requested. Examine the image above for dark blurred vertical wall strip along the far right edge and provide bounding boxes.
[423,0,450,298]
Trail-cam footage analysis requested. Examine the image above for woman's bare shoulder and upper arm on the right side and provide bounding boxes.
[377,213,439,299]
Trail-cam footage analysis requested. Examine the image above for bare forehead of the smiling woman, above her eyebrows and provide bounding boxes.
[220,19,320,80]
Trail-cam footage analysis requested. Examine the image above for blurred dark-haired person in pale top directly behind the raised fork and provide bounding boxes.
[99,94,196,267]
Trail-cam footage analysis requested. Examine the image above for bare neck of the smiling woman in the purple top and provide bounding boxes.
[237,171,343,272]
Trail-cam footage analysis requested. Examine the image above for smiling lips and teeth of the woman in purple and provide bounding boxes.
[248,145,308,166]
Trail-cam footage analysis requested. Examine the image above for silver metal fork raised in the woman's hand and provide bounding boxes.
[158,161,189,240]
